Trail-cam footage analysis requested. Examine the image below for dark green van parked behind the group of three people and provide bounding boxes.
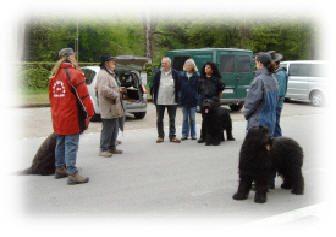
[165,48,254,111]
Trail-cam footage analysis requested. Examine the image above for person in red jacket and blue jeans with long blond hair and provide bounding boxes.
[49,48,94,184]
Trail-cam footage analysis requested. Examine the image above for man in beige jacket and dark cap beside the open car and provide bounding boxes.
[97,53,123,158]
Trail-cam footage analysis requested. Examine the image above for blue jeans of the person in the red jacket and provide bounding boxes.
[55,134,79,174]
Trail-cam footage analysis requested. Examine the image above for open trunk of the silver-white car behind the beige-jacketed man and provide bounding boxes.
[116,70,144,102]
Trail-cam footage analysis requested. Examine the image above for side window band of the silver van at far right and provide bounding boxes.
[289,64,325,77]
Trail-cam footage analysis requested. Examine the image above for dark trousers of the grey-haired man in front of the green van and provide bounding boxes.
[156,105,177,139]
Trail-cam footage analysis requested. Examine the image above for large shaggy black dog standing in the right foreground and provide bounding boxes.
[232,126,304,203]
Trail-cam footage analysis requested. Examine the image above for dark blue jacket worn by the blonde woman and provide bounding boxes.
[180,71,199,108]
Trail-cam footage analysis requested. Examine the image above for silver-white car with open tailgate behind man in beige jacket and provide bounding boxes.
[81,56,147,121]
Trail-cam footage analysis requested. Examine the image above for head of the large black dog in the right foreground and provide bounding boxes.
[246,126,272,151]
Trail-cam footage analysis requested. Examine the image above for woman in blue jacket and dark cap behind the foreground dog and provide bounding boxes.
[243,53,279,136]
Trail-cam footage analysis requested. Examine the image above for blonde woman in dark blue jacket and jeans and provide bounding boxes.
[180,58,199,141]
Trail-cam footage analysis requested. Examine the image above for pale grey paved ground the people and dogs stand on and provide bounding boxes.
[11,103,325,226]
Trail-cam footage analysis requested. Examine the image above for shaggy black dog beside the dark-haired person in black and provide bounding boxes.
[202,99,235,146]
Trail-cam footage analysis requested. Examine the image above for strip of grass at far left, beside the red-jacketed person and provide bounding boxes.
[19,88,49,104]
